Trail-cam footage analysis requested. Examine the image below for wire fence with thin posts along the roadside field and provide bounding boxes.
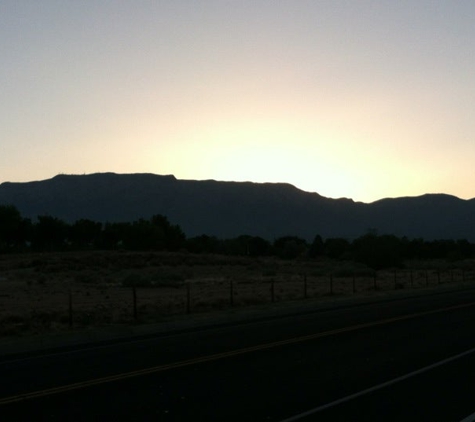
[0,270,475,335]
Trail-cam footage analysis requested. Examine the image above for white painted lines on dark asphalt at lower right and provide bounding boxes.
[281,348,475,422]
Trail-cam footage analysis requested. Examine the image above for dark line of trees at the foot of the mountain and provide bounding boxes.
[0,205,475,269]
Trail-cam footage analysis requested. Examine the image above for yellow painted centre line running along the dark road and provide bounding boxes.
[0,302,475,406]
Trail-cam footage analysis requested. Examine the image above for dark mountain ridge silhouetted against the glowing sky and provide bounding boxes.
[0,173,475,242]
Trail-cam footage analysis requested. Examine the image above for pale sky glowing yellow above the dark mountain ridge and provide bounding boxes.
[0,0,475,202]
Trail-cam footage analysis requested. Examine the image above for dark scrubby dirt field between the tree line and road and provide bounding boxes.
[0,252,475,336]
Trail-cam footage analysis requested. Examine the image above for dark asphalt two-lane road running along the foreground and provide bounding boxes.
[0,289,475,422]
